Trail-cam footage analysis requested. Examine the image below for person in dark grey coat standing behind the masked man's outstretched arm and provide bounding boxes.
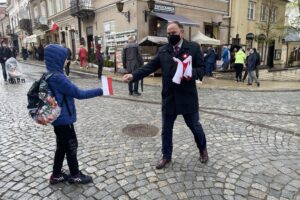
[122,37,144,96]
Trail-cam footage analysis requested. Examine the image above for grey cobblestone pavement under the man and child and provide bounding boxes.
[0,65,300,200]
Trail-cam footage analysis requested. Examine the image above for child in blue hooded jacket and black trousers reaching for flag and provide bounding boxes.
[41,44,103,184]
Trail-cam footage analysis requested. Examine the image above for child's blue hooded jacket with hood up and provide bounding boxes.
[45,44,103,126]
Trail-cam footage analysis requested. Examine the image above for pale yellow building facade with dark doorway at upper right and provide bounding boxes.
[230,0,288,67]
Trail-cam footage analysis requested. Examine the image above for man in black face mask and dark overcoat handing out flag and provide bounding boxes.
[123,22,208,169]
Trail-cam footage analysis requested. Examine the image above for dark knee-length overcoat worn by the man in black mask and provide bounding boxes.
[133,40,204,114]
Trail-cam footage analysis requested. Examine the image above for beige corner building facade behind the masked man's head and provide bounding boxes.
[82,0,230,57]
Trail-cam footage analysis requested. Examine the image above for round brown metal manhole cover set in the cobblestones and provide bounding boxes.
[122,124,159,137]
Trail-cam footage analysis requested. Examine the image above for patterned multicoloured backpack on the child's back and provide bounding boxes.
[27,73,61,125]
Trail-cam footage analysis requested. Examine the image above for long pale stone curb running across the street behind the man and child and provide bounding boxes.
[18,60,300,92]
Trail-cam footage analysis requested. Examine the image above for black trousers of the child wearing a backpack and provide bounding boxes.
[53,124,79,176]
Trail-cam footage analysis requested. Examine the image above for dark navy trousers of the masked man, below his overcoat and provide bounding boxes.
[161,112,206,159]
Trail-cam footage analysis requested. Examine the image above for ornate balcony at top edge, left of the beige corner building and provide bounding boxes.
[71,0,95,18]
